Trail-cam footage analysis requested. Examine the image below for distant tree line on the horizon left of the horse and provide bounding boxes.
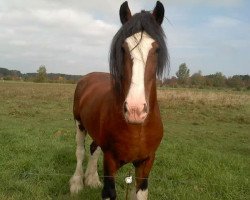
[0,65,82,83]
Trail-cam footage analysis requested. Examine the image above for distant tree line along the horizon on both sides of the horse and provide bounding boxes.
[0,63,250,90]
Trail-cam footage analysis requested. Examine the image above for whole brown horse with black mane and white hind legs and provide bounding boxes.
[70,1,168,200]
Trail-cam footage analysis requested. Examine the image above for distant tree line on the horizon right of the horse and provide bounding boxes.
[161,63,250,90]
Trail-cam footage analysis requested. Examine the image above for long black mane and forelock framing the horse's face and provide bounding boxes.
[109,11,169,94]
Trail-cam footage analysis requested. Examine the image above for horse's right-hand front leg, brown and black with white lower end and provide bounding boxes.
[132,155,155,200]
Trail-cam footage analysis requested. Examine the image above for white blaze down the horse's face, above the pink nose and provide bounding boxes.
[126,32,154,107]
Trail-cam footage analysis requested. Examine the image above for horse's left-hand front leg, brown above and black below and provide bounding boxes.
[102,152,119,200]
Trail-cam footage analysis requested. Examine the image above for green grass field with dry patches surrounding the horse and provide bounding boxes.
[0,82,250,200]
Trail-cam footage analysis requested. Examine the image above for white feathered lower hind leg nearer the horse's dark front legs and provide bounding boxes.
[84,147,102,188]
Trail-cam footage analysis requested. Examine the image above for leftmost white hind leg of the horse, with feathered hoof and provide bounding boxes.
[70,121,86,194]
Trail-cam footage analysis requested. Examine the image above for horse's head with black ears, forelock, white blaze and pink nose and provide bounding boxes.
[110,1,168,124]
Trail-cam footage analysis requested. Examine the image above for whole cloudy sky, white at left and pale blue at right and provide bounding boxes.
[0,0,250,76]
